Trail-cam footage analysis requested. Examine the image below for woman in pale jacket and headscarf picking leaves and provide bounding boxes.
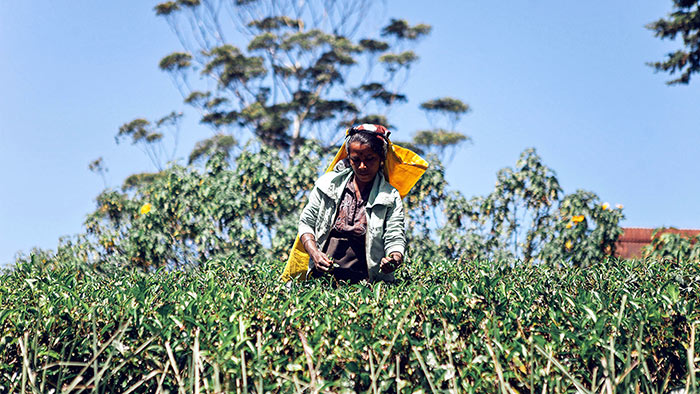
[299,124,406,282]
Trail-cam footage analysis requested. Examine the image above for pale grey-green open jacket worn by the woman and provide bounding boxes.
[299,166,406,282]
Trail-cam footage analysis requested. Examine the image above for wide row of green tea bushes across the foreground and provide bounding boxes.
[0,258,700,393]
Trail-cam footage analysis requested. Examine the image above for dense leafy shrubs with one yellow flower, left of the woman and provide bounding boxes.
[86,143,320,270]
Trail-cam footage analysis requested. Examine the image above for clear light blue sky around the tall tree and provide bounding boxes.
[0,0,700,263]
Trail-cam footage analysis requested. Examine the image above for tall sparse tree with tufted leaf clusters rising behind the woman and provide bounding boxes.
[147,0,466,161]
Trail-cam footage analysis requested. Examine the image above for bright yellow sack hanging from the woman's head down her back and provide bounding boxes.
[280,142,428,282]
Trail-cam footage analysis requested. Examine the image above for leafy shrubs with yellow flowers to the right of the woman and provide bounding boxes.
[405,149,623,266]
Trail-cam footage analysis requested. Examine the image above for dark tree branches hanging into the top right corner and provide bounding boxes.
[647,0,700,85]
